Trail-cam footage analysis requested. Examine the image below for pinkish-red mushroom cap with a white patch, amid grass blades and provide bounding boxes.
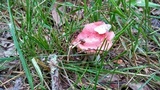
[72,21,115,53]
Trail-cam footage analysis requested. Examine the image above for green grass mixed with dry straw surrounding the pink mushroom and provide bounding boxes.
[0,0,160,90]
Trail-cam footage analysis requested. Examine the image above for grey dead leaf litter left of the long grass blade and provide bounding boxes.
[0,22,25,90]
